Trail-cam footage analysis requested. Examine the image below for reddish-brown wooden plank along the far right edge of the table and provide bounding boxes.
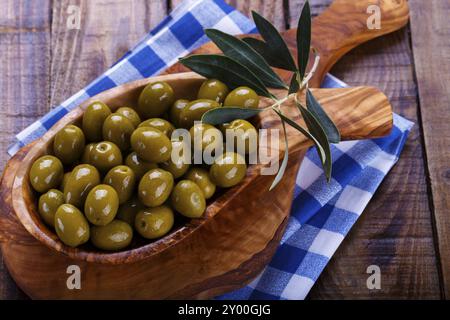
[410,0,450,299]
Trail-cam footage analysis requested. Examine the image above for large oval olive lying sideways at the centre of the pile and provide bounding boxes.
[131,127,172,163]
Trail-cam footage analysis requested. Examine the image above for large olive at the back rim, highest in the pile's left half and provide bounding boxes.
[137,81,175,119]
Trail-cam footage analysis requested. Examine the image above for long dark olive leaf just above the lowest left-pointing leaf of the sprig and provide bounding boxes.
[205,29,287,89]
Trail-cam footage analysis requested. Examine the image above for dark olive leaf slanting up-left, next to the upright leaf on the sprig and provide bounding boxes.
[252,11,297,72]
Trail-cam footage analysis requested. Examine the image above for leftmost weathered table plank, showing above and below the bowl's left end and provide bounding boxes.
[0,0,50,300]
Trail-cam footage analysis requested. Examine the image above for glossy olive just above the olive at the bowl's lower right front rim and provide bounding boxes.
[138,169,173,207]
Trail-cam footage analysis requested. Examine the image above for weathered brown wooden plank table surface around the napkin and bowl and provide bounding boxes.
[0,0,450,299]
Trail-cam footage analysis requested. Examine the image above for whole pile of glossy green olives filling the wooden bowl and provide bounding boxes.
[29,79,259,251]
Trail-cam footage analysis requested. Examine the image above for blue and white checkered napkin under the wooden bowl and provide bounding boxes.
[8,0,413,299]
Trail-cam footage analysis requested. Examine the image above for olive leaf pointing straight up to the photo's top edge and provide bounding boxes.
[297,1,311,79]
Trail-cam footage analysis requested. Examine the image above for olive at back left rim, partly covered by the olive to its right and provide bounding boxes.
[81,101,111,142]
